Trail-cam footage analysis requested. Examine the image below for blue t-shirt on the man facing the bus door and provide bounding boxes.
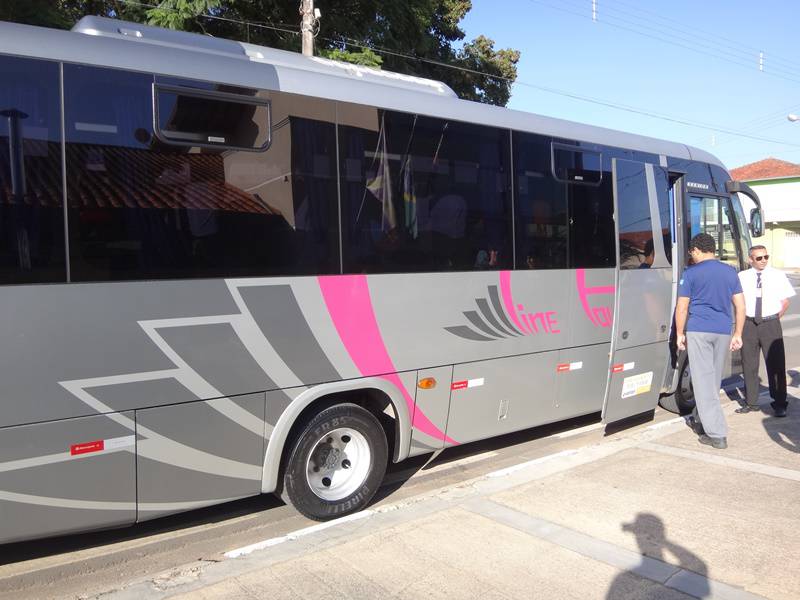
[678,260,742,335]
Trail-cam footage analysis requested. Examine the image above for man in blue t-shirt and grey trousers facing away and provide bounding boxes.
[675,233,745,450]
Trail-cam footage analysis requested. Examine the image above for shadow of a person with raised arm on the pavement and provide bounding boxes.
[606,513,711,600]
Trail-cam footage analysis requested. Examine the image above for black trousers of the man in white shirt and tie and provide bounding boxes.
[742,318,787,408]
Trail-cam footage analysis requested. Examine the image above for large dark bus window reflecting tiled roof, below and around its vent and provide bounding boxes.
[64,66,339,281]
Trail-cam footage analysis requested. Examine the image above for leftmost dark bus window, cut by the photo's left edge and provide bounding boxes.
[0,57,66,284]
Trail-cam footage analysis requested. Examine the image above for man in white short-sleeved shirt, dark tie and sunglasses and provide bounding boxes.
[736,246,795,417]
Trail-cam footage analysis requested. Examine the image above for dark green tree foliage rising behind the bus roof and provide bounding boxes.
[0,0,520,105]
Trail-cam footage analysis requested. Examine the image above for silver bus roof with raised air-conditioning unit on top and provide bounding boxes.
[0,17,724,168]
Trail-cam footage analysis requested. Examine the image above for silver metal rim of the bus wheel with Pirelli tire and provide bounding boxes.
[306,427,372,502]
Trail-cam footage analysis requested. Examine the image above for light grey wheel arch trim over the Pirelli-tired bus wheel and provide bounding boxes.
[261,377,411,494]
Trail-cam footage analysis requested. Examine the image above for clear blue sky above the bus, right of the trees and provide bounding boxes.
[461,0,800,169]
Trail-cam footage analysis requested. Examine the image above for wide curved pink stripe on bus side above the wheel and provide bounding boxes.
[317,275,458,444]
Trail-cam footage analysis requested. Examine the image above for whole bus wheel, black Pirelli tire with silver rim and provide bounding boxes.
[283,404,389,521]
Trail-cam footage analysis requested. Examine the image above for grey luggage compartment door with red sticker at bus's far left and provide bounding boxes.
[0,412,136,543]
